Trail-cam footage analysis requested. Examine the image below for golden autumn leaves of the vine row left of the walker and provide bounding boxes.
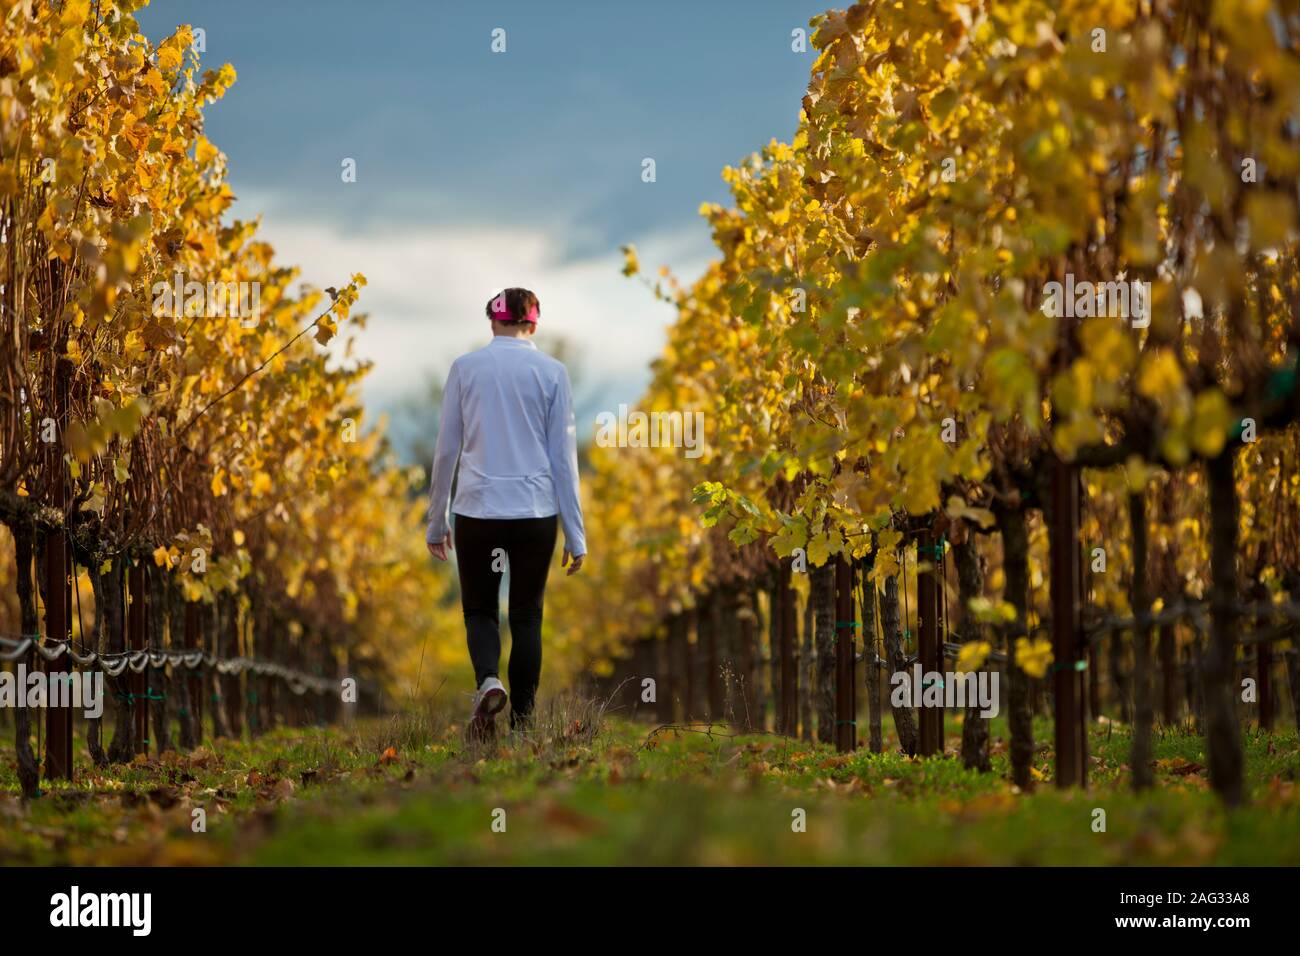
[0,0,467,790]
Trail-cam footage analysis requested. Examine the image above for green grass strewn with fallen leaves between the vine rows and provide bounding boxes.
[0,701,1300,866]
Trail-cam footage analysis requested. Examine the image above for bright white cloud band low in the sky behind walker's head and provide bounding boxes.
[239,198,712,408]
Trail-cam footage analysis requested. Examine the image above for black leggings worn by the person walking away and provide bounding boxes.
[455,515,558,726]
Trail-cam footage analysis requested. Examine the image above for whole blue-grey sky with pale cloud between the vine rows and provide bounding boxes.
[138,0,826,455]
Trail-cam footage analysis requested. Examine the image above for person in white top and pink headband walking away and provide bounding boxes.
[425,289,586,740]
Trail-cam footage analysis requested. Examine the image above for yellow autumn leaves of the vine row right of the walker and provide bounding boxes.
[566,0,1300,800]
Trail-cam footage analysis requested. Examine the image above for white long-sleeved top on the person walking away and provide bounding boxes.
[425,336,586,555]
